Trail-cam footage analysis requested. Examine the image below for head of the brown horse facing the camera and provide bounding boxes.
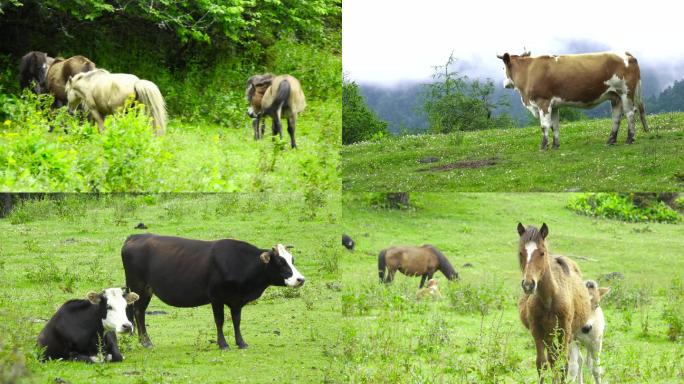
[518,223,550,295]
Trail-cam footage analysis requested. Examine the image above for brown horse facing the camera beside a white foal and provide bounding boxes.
[518,223,591,382]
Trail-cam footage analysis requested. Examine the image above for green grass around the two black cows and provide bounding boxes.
[0,193,343,383]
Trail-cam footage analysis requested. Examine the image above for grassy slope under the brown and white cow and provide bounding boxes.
[342,113,684,192]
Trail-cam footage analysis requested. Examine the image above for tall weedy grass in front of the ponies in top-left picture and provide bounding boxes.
[0,96,341,192]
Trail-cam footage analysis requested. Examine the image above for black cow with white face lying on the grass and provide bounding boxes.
[38,288,138,363]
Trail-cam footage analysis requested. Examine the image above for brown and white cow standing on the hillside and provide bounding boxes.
[497,52,648,149]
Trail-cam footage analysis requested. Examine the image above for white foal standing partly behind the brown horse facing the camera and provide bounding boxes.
[569,280,610,384]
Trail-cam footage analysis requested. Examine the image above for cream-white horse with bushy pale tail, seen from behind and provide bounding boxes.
[65,69,167,135]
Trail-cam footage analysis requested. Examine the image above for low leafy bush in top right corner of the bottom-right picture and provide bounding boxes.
[567,193,681,223]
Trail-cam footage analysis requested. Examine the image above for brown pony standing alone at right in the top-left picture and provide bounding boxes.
[246,73,306,148]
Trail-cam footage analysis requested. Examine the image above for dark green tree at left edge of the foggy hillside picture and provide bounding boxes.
[342,79,387,145]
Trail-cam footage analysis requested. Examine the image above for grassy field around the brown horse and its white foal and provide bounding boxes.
[333,193,684,383]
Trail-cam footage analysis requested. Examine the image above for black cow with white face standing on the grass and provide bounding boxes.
[121,234,304,349]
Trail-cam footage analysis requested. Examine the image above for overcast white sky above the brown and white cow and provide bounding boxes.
[342,0,684,85]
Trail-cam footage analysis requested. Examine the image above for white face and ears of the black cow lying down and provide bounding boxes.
[88,288,138,333]
